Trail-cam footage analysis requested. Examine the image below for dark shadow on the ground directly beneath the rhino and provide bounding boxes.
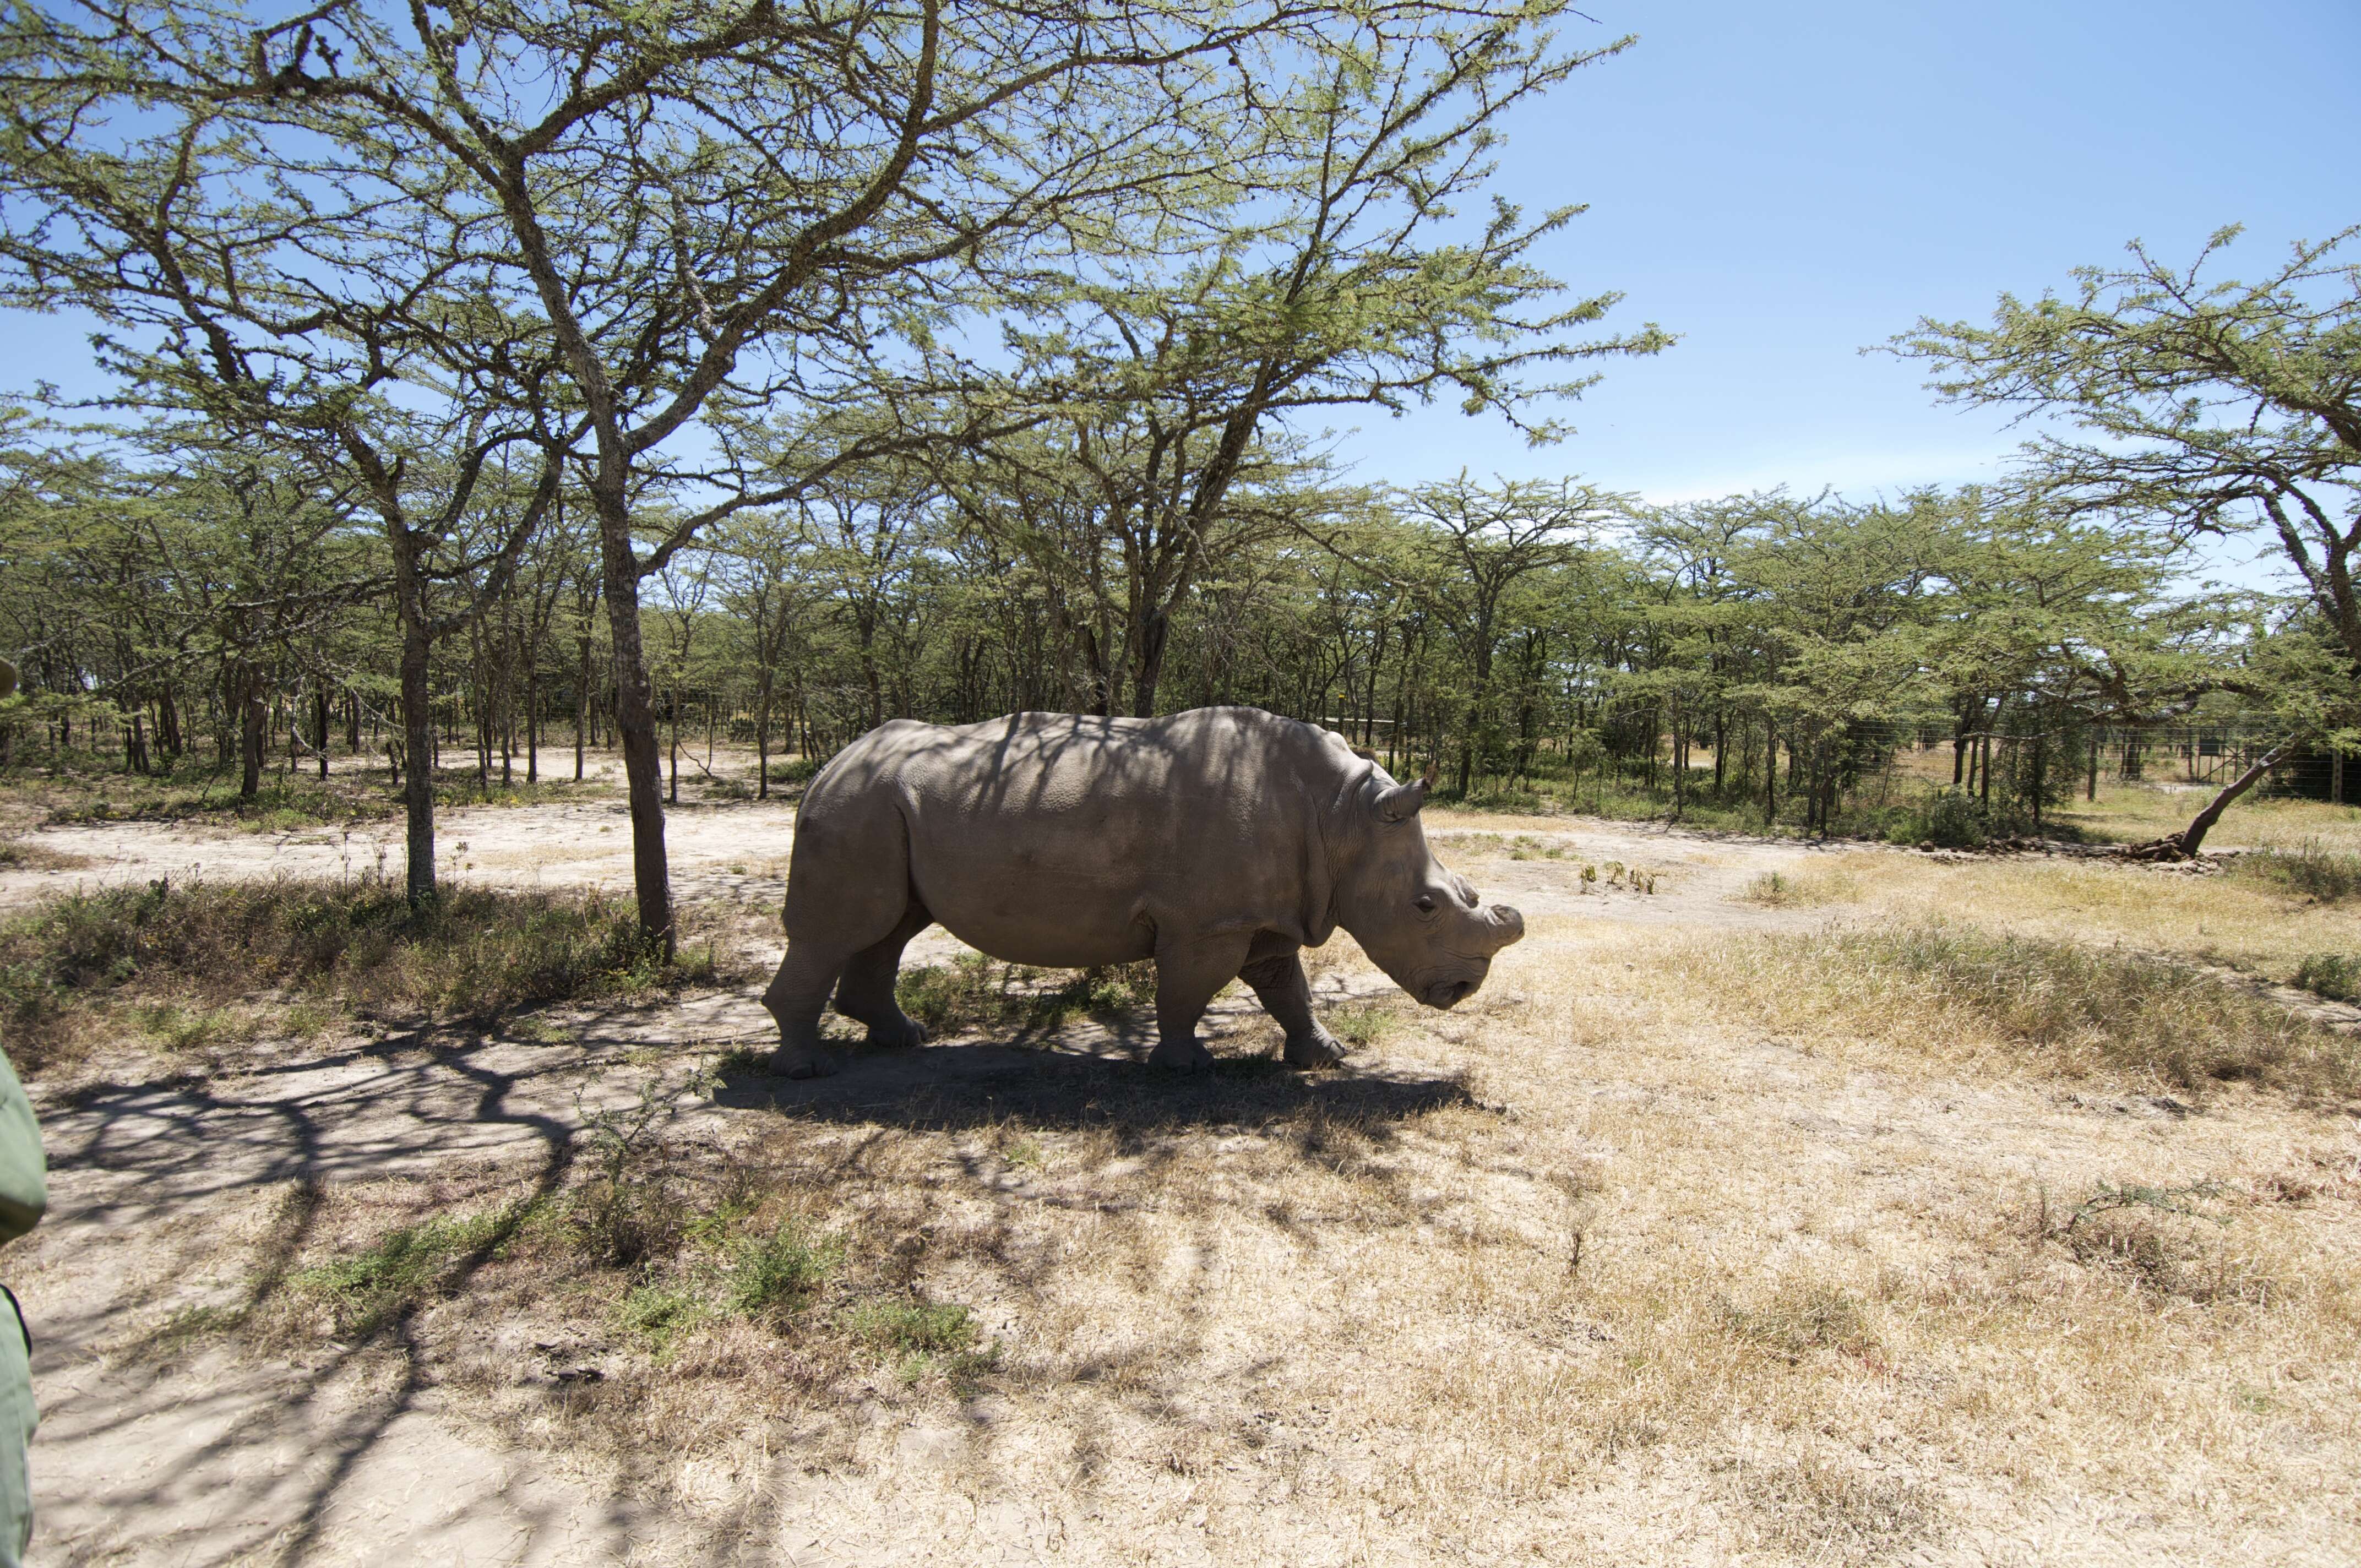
[713,1042,1478,1131]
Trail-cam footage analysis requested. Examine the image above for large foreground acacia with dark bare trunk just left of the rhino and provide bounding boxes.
[203,0,1359,949]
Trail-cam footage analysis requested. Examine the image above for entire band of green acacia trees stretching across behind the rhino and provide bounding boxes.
[0,0,2361,952]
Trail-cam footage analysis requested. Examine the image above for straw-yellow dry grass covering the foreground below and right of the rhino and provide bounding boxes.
[23,822,2361,1563]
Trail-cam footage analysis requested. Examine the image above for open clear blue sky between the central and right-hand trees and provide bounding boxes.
[1339,0,2361,545]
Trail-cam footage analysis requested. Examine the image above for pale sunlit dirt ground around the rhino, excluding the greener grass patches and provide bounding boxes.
[0,801,2361,1566]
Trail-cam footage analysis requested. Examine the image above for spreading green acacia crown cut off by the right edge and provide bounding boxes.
[1891,229,2361,661]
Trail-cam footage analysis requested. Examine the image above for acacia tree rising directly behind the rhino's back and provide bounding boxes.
[973,0,1669,716]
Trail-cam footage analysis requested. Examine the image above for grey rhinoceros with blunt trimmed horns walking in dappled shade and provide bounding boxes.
[763,709,1525,1077]
